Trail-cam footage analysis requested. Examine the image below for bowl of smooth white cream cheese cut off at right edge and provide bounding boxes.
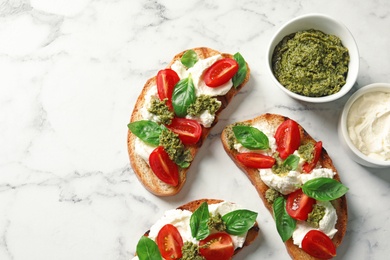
[338,83,390,168]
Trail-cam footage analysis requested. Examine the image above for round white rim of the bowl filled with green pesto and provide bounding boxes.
[266,13,360,103]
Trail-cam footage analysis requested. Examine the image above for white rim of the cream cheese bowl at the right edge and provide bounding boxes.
[340,82,390,167]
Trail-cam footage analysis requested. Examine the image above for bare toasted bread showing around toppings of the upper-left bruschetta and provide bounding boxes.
[127,47,250,196]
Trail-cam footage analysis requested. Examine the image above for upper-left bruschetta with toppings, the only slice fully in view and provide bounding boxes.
[127,48,250,196]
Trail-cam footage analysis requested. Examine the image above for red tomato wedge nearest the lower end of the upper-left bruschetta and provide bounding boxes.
[149,146,179,186]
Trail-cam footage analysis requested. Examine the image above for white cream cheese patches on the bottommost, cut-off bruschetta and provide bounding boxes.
[149,201,247,249]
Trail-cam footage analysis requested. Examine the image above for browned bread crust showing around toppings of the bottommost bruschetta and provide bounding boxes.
[139,199,260,255]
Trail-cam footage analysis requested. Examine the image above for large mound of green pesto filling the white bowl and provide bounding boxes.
[272,29,350,97]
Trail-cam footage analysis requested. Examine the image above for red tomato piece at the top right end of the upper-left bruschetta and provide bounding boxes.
[204,58,238,88]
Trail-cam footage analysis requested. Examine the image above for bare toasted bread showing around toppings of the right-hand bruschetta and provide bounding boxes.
[221,114,348,260]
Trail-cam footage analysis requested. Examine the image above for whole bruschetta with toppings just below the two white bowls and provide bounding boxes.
[221,114,348,260]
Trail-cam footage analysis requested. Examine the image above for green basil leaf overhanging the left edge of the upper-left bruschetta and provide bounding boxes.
[127,120,164,146]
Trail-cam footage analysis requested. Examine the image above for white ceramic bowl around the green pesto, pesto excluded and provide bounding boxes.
[267,14,359,103]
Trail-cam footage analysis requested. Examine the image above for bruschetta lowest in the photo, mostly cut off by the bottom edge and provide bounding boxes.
[133,199,259,260]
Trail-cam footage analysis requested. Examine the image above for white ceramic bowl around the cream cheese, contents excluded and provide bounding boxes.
[338,83,390,168]
